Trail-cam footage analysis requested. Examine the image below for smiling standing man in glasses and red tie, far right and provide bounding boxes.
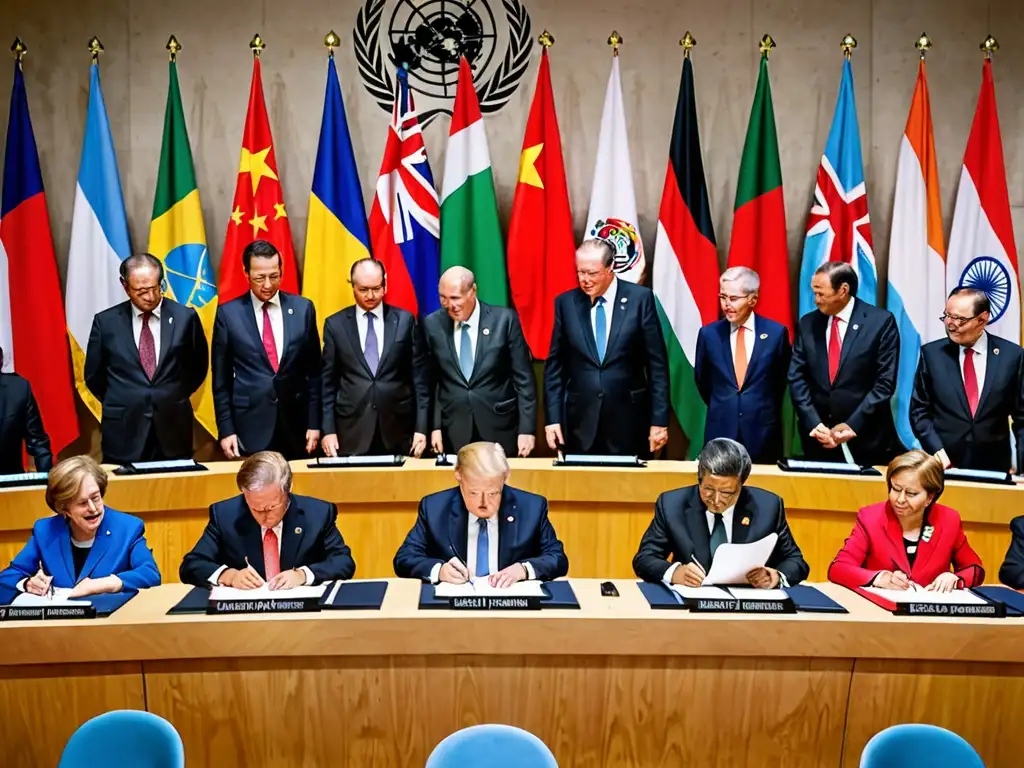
[910,288,1024,472]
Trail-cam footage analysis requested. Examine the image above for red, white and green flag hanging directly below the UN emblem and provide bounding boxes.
[441,56,509,306]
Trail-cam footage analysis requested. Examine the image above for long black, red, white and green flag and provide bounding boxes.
[652,57,718,458]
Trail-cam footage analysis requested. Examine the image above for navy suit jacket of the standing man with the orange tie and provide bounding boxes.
[693,314,791,464]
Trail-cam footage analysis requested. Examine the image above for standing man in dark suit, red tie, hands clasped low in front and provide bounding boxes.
[790,261,902,465]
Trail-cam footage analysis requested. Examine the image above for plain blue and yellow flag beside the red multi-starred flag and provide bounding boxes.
[302,53,370,321]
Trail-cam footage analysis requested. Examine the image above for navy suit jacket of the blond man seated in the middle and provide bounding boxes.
[394,485,569,581]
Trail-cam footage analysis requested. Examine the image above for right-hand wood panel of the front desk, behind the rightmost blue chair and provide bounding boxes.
[843,659,1024,768]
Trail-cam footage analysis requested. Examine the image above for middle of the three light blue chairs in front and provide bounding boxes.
[426,725,558,768]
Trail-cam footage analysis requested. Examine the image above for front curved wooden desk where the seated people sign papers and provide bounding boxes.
[0,580,1024,768]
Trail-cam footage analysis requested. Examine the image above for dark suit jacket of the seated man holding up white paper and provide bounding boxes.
[633,485,810,587]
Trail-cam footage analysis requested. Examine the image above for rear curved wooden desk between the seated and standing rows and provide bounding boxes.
[0,459,1024,582]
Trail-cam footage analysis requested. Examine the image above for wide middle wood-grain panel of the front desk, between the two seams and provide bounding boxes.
[145,656,851,768]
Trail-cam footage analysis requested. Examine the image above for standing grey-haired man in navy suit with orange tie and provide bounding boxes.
[693,266,791,464]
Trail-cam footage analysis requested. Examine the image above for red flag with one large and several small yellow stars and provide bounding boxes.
[217,55,299,304]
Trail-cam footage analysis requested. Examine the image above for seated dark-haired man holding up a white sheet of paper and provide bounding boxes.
[633,437,810,589]
